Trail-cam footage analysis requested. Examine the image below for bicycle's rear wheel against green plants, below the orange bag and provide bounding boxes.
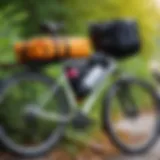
[0,72,69,157]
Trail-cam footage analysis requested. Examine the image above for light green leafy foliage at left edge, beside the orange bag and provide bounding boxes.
[0,6,26,62]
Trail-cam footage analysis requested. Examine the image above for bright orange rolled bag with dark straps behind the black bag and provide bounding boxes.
[15,37,91,63]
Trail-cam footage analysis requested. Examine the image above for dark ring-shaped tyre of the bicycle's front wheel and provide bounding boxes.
[102,78,160,155]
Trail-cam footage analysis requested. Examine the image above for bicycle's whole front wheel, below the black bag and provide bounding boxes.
[102,78,160,154]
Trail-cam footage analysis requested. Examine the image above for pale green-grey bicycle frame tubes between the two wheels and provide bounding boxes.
[31,57,117,122]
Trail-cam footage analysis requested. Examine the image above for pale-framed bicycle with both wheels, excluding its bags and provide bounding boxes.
[0,21,160,157]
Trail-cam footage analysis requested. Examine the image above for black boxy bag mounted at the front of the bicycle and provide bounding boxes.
[89,20,140,59]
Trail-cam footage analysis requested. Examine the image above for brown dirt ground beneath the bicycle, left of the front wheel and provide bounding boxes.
[0,132,119,160]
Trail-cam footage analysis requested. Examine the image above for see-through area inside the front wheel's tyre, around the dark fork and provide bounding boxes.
[108,82,158,150]
